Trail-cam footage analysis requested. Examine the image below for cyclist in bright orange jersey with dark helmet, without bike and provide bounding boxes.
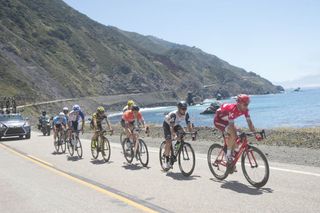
[122,105,147,156]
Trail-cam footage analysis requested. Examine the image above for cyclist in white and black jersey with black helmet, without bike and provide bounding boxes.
[163,101,193,168]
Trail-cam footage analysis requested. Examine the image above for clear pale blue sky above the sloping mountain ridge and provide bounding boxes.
[64,0,320,83]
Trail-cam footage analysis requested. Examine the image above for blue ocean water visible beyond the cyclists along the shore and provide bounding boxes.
[109,88,320,129]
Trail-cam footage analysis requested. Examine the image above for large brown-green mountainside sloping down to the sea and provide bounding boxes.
[0,0,282,100]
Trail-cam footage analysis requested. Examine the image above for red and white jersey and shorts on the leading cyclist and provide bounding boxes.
[214,104,250,131]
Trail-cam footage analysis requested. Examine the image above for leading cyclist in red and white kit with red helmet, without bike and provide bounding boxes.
[214,94,262,169]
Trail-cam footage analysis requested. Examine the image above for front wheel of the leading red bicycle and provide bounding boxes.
[241,146,270,188]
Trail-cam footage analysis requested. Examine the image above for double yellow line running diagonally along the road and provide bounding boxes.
[0,143,157,213]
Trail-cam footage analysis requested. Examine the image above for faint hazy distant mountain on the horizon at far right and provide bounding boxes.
[279,74,320,88]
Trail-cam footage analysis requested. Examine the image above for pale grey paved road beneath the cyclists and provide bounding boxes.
[0,133,320,212]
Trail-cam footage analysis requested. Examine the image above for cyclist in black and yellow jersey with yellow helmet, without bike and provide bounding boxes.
[91,106,113,148]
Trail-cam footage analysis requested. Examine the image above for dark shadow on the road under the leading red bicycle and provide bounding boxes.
[214,178,273,195]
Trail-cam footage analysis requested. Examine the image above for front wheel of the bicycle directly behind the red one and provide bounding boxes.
[178,143,196,177]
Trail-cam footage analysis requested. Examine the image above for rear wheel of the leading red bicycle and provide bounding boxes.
[207,144,228,180]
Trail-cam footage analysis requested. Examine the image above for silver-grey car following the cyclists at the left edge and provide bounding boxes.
[0,114,31,140]
